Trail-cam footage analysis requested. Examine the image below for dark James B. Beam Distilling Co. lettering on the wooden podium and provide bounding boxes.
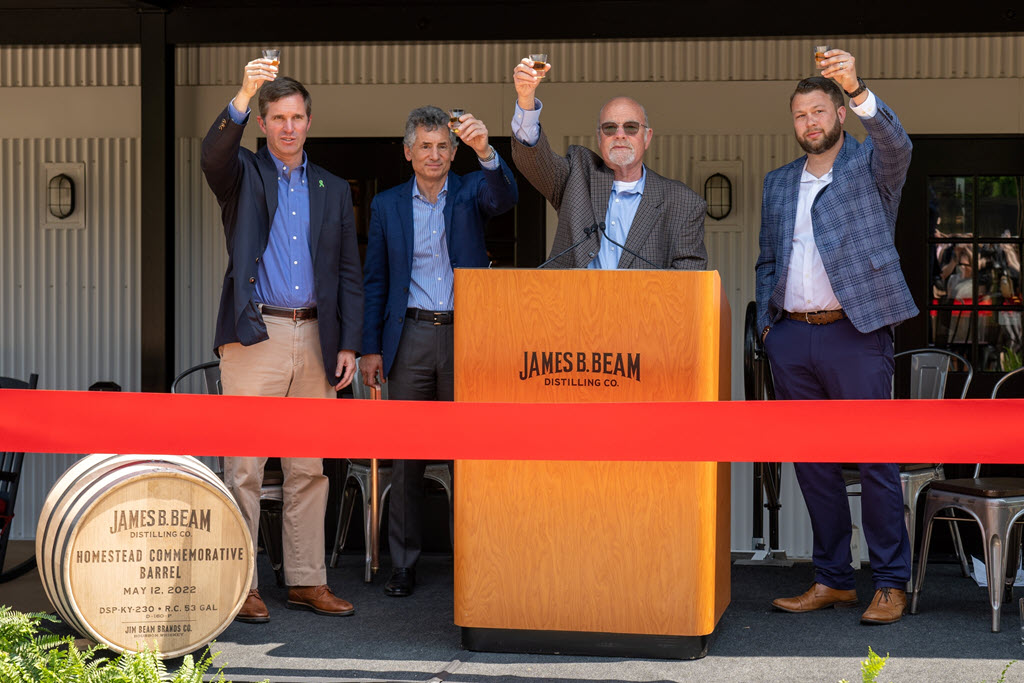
[519,351,640,390]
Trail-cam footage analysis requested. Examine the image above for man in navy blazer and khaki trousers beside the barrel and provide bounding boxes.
[202,59,362,623]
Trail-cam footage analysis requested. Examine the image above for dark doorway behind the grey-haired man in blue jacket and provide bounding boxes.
[299,137,547,268]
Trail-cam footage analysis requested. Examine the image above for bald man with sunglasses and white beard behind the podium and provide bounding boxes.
[512,59,708,270]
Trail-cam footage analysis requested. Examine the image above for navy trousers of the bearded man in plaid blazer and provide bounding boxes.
[765,318,910,590]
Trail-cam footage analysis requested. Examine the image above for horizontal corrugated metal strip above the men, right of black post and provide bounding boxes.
[177,35,1024,85]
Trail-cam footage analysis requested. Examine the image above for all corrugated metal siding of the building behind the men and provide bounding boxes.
[6,35,1024,557]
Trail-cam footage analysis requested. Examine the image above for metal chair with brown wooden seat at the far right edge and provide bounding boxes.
[910,368,1024,633]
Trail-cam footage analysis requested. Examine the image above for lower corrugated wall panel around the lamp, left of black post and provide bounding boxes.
[0,138,140,539]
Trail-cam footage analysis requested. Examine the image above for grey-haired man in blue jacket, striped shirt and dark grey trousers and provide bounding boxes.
[359,106,518,597]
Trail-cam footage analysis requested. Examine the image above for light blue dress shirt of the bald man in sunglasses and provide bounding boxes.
[512,99,647,270]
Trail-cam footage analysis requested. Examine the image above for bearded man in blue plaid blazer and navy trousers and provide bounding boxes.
[757,49,918,624]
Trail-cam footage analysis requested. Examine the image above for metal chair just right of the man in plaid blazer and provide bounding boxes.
[843,347,974,591]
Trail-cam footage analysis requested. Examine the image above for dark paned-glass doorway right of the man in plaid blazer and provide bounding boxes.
[896,135,1024,398]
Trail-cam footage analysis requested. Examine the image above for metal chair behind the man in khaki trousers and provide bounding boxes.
[171,360,285,586]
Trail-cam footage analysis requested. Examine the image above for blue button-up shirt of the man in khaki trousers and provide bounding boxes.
[227,100,316,308]
